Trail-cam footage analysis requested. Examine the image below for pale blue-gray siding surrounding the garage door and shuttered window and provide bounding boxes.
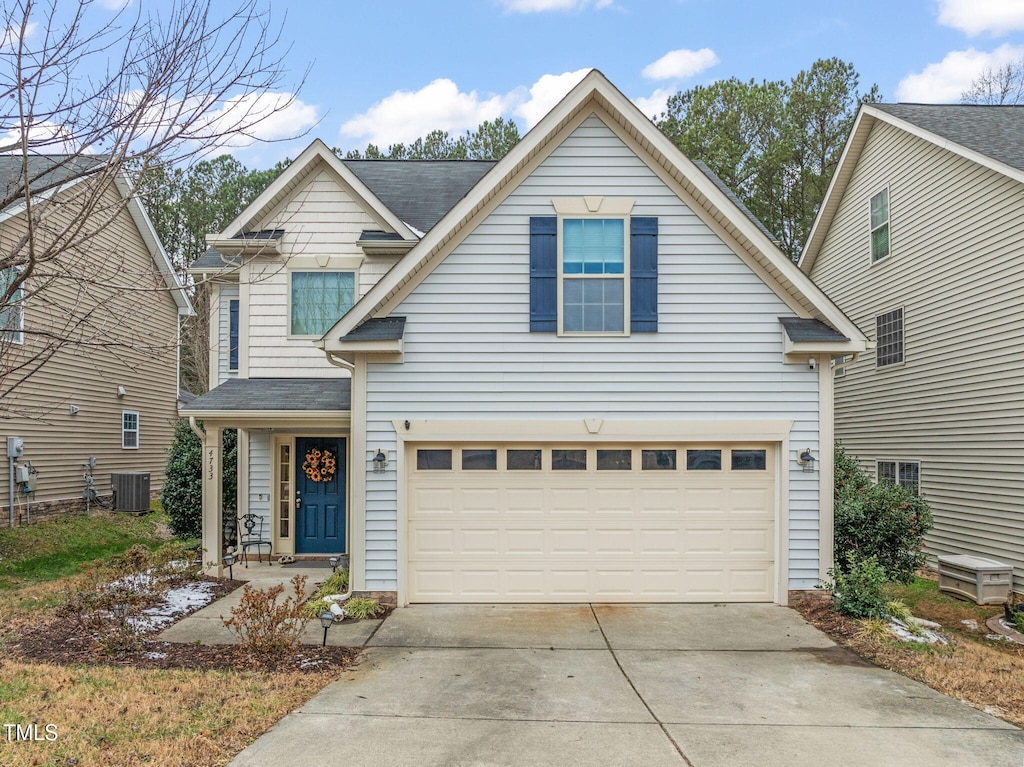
[366,117,818,590]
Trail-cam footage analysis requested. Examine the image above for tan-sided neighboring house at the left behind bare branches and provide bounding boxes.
[0,156,190,525]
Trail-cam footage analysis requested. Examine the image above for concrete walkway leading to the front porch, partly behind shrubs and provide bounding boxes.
[157,562,381,647]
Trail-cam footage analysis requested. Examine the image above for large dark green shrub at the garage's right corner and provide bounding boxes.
[836,445,932,584]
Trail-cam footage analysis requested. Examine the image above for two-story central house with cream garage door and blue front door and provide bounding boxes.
[181,71,865,604]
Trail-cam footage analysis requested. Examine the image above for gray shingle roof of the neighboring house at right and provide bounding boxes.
[871,103,1024,170]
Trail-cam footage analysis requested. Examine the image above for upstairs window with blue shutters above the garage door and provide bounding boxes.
[529,216,657,334]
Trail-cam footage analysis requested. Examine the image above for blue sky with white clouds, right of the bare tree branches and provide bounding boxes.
[59,0,1024,167]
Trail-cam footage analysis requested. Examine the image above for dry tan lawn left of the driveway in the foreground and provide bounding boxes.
[0,661,336,767]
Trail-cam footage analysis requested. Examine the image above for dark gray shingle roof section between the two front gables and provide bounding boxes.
[344,160,495,233]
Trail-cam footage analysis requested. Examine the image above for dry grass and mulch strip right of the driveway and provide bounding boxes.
[791,593,1024,726]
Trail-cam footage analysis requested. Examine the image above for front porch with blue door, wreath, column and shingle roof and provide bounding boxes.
[179,378,357,577]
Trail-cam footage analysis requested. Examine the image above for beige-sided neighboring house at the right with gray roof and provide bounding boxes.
[800,103,1024,590]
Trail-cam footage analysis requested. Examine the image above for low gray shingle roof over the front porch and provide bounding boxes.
[180,378,352,412]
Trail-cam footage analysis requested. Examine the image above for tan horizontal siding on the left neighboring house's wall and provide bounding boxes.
[0,182,178,514]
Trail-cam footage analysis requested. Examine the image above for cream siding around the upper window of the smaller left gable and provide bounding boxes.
[240,170,386,378]
